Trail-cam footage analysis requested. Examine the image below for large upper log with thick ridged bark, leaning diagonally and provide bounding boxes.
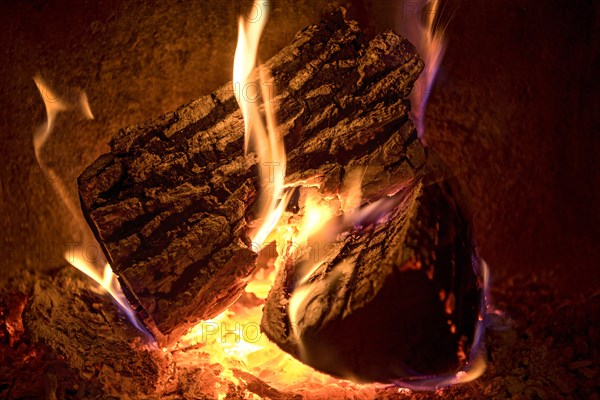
[79,11,425,343]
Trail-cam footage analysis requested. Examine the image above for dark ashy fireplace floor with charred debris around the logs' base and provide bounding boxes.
[0,266,600,399]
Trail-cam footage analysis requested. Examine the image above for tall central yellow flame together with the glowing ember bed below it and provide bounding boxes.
[177,1,382,398]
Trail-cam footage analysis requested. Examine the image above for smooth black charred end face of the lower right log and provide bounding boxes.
[302,269,458,382]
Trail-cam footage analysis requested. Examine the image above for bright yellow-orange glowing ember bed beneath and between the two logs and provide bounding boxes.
[168,206,380,399]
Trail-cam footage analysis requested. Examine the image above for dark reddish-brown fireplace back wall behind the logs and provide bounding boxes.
[0,0,600,292]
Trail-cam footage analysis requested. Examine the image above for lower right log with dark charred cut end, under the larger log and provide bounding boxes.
[261,177,481,383]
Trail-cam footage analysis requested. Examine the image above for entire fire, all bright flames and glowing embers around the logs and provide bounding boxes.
[33,0,489,399]
